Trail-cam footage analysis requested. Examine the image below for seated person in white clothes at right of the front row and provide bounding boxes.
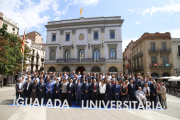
[136,87,147,105]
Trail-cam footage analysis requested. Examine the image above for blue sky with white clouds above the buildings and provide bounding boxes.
[0,0,180,51]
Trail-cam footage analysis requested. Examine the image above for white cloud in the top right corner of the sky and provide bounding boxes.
[142,0,180,15]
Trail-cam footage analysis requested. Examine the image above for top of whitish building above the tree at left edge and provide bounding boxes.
[0,12,19,35]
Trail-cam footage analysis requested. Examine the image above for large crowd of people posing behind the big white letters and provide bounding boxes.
[16,71,167,109]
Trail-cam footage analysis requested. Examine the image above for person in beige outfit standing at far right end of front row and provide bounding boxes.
[158,82,167,109]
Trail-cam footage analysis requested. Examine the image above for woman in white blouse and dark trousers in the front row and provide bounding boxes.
[99,80,106,100]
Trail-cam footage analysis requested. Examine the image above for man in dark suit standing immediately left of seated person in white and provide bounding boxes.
[128,80,137,102]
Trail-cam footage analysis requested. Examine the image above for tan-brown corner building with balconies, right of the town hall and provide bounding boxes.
[131,32,174,78]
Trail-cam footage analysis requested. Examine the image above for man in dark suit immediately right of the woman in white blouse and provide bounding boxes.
[106,80,114,102]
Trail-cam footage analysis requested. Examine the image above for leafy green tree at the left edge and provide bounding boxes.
[0,24,31,85]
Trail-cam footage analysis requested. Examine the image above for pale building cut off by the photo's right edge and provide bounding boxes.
[171,38,180,76]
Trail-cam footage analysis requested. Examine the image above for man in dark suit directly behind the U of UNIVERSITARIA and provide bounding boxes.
[83,79,90,105]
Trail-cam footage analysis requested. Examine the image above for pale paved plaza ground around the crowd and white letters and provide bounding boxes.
[0,86,180,120]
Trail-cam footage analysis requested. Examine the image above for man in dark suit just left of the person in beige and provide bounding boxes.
[150,80,157,107]
